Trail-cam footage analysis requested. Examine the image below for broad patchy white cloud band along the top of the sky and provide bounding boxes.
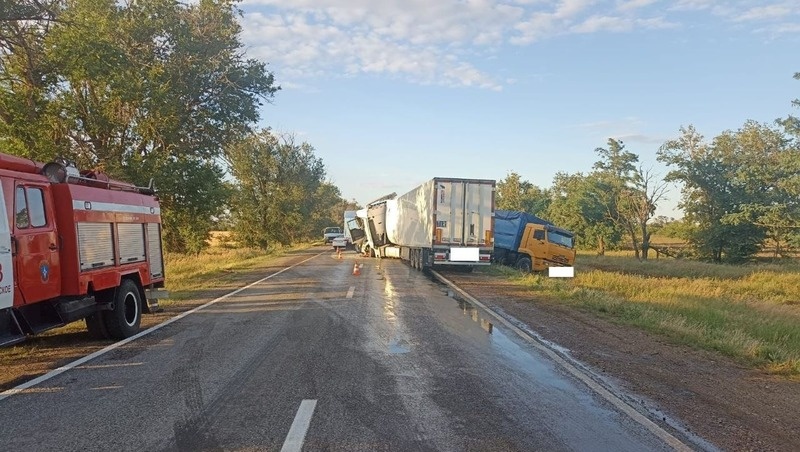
[241,0,795,90]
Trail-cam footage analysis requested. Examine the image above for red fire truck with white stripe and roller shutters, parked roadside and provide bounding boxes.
[0,154,168,346]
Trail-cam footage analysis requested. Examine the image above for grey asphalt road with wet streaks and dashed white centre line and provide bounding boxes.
[0,248,670,451]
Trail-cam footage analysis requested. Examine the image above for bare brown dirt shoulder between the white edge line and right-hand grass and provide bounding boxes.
[446,273,800,450]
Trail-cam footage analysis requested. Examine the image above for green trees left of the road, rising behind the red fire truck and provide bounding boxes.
[0,0,347,252]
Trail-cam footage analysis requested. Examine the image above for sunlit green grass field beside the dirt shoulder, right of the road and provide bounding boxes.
[488,255,800,378]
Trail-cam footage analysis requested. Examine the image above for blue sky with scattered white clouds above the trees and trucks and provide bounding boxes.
[234,0,800,217]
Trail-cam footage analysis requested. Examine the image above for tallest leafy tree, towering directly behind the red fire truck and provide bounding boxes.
[0,0,279,251]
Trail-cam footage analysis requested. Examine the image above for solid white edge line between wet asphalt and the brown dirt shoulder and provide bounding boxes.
[431,271,692,452]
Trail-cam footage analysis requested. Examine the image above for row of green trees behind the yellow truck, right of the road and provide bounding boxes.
[497,85,800,262]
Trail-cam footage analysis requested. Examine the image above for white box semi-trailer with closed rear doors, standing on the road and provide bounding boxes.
[380,177,495,270]
